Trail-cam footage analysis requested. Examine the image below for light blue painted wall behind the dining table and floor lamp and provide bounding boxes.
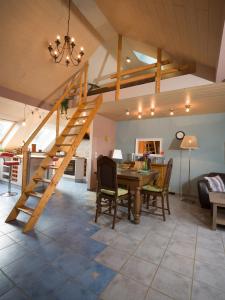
[116,113,225,195]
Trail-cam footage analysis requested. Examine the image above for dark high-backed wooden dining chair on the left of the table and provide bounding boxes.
[95,155,131,229]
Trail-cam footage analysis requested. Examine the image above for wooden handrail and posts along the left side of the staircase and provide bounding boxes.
[22,63,88,191]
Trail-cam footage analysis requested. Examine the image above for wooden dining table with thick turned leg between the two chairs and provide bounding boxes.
[117,168,159,224]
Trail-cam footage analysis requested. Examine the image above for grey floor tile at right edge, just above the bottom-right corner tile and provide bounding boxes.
[194,261,225,291]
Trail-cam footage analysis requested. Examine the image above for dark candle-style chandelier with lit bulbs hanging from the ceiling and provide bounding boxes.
[48,0,84,67]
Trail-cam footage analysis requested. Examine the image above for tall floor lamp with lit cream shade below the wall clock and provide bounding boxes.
[180,135,199,202]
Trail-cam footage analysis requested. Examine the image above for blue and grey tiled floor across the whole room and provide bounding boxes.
[0,180,225,300]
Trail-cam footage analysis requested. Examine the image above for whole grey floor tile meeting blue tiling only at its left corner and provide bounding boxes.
[120,256,158,286]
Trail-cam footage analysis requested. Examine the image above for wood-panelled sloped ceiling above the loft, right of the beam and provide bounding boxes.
[96,0,225,68]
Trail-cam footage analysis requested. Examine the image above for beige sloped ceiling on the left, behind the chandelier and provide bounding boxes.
[0,0,100,106]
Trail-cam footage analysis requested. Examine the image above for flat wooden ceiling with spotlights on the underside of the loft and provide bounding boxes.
[99,83,225,121]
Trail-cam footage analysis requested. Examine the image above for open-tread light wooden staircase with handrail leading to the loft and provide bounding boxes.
[6,62,102,232]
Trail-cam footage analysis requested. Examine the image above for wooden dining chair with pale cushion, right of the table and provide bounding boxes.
[141,158,173,221]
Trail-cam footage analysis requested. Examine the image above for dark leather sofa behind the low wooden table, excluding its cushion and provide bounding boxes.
[197,172,225,208]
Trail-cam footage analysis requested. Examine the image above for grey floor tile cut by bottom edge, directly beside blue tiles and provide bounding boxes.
[100,274,147,300]
